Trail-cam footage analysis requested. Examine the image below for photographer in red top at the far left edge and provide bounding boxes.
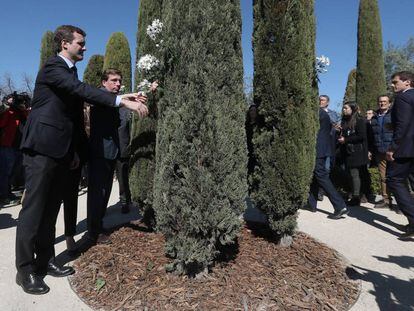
[0,92,30,207]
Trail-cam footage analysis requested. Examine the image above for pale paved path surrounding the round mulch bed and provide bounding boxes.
[0,184,414,311]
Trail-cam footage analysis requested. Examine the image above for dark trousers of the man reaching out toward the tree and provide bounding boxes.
[16,153,69,274]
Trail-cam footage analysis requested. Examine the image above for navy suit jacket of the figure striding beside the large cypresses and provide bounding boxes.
[316,108,334,158]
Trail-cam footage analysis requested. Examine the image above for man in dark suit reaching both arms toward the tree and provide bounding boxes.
[16,25,148,294]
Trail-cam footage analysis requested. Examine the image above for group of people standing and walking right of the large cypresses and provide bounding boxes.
[308,71,414,238]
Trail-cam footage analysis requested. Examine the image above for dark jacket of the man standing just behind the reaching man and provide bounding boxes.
[89,88,120,160]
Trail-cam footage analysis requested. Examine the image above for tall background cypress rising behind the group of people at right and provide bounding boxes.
[356,0,387,111]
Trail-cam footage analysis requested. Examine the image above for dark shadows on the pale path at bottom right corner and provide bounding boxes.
[346,264,414,311]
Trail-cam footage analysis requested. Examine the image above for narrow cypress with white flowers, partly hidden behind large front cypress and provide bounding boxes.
[130,0,162,227]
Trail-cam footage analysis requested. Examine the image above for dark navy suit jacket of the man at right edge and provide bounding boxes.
[389,89,414,158]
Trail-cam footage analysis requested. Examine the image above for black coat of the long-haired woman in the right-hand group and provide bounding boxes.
[341,117,368,168]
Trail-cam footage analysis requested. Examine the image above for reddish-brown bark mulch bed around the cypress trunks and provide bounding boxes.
[70,226,360,311]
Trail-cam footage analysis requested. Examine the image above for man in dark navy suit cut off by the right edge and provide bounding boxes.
[386,71,414,237]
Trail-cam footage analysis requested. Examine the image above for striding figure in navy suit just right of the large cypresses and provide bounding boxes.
[308,108,348,219]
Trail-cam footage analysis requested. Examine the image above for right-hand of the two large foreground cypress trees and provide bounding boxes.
[249,0,318,244]
